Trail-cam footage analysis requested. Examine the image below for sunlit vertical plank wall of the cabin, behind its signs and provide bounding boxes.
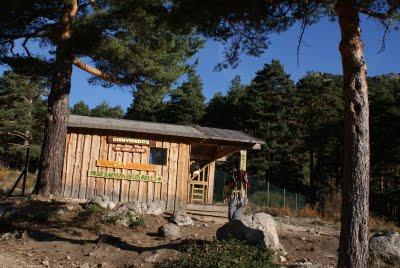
[62,131,190,211]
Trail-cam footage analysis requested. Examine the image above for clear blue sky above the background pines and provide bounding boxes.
[8,15,400,109]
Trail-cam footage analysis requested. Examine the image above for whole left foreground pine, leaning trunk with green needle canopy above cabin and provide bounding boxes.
[0,0,201,194]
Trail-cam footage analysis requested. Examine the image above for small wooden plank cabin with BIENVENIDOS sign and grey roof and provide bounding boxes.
[61,115,263,211]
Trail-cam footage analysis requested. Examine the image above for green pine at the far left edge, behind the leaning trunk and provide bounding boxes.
[0,72,45,168]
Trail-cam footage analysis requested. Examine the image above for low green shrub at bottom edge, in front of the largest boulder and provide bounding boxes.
[161,240,279,268]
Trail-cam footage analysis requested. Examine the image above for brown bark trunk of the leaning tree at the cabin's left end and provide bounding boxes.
[34,0,78,195]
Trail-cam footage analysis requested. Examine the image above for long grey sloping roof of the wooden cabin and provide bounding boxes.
[68,115,265,144]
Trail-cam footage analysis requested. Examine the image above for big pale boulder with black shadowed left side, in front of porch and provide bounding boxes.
[217,212,282,250]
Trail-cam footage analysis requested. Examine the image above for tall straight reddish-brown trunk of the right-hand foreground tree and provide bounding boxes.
[335,0,370,268]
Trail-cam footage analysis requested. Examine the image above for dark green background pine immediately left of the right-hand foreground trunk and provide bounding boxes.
[295,72,343,204]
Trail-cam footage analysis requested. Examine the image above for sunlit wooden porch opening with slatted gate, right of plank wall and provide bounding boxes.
[188,162,215,204]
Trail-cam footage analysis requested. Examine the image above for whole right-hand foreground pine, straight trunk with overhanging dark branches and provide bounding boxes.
[172,0,400,267]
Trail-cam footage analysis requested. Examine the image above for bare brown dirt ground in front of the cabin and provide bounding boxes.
[0,198,339,268]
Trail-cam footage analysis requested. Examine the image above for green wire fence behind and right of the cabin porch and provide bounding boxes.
[214,170,306,210]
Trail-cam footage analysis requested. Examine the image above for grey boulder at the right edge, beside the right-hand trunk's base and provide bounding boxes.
[369,232,400,267]
